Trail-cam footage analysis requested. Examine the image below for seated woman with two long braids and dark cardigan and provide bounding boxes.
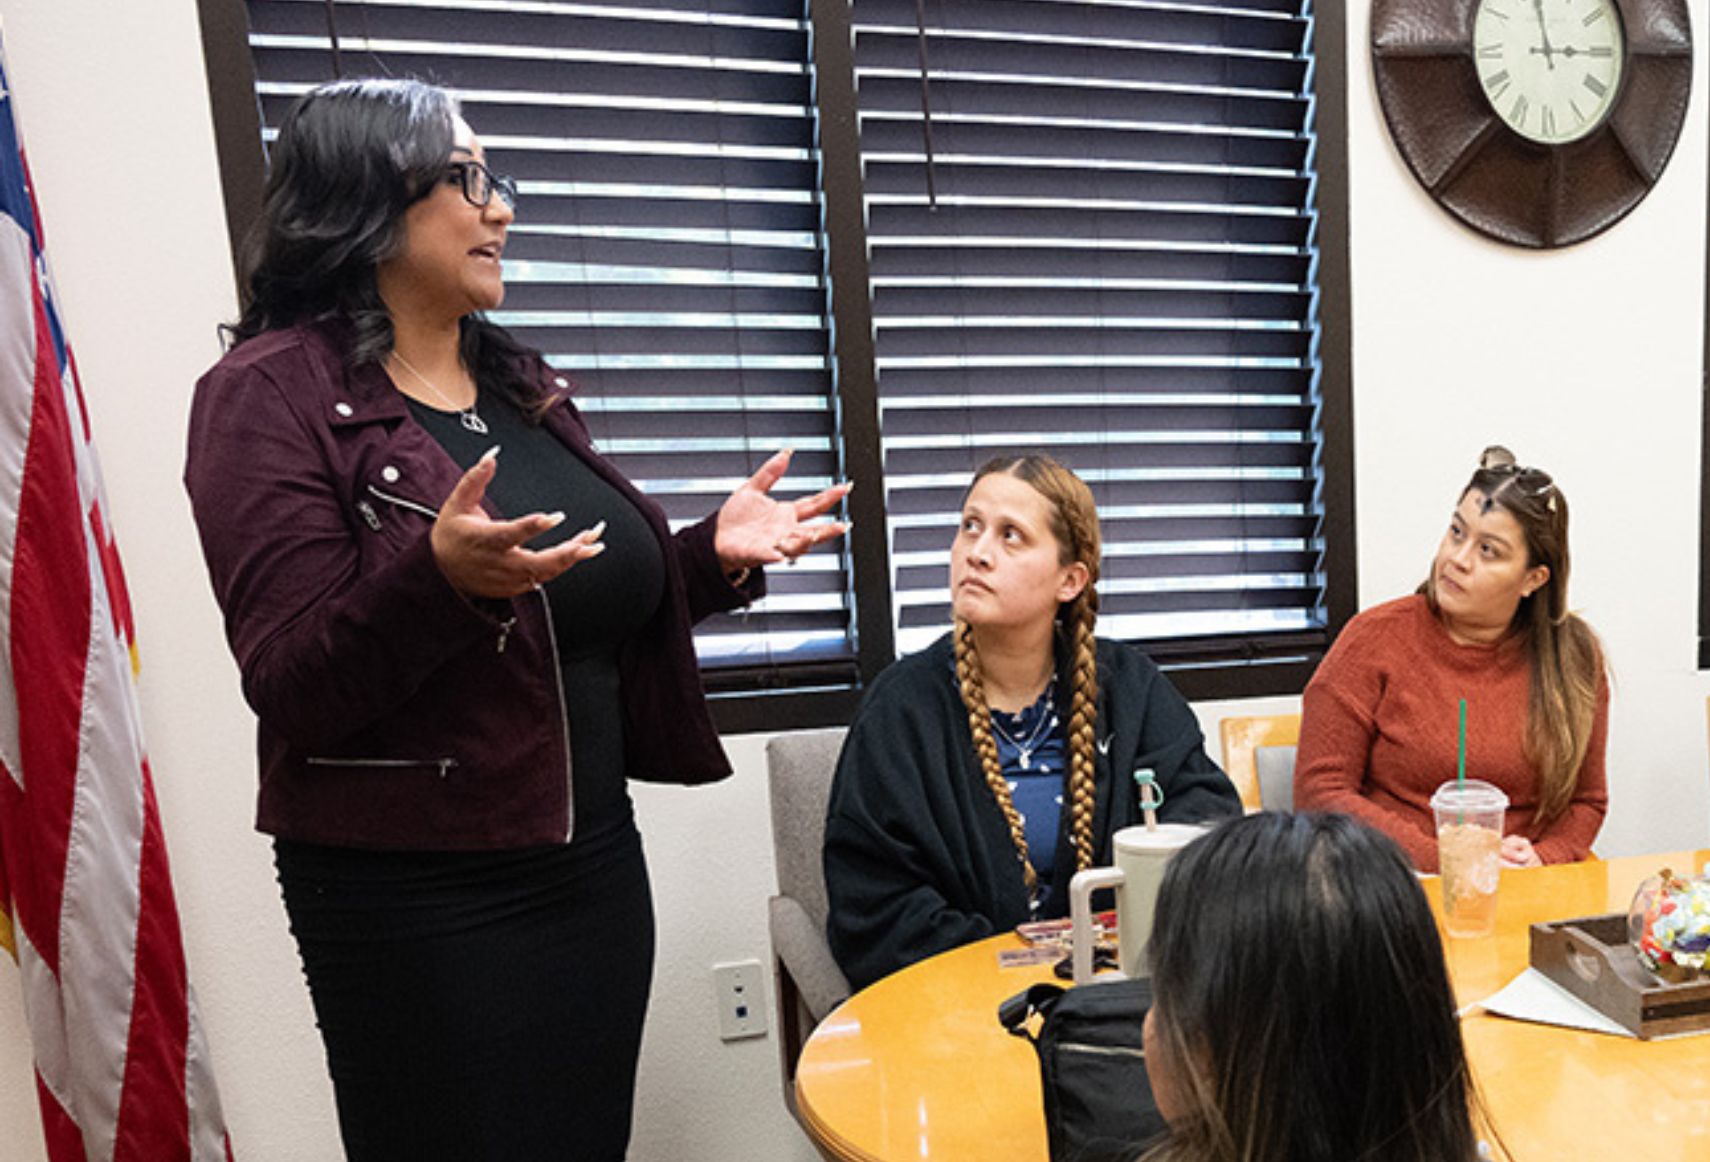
[824,456,1240,988]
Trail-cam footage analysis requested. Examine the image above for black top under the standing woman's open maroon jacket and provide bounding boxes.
[409,391,665,846]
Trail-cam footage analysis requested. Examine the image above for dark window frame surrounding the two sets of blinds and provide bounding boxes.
[197,0,1354,733]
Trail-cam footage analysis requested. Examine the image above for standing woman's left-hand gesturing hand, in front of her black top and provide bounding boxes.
[431,448,605,596]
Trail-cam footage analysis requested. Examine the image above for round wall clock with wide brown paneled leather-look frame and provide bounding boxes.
[1371,0,1693,246]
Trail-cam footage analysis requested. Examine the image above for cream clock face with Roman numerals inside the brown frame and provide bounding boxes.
[1472,0,1623,145]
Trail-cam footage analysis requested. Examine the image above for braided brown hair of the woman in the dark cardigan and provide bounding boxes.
[956,455,1103,892]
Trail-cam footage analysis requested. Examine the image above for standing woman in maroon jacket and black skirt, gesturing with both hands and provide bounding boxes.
[185,80,845,1162]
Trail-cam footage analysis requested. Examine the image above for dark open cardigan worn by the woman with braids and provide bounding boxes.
[824,634,1241,988]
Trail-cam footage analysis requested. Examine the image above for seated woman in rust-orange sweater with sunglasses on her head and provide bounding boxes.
[1294,446,1609,872]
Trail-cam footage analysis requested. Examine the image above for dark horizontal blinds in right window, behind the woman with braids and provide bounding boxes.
[852,0,1324,653]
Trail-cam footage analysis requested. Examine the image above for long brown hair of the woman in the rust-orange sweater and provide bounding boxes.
[1419,444,1604,824]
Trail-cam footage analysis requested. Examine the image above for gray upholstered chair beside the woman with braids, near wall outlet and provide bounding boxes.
[766,726,850,1111]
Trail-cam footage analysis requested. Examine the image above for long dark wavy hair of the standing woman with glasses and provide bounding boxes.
[222,79,542,412]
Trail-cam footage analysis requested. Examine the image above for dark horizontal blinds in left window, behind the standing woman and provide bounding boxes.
[250,0,853,682]
